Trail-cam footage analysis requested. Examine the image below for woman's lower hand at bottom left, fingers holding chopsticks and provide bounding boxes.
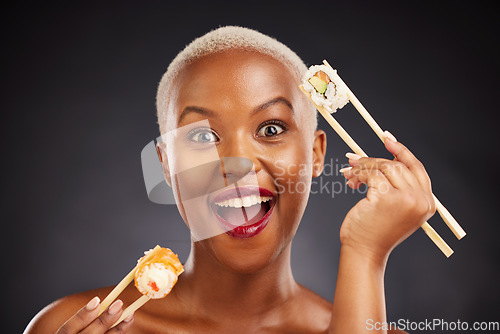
[57,297,134,334]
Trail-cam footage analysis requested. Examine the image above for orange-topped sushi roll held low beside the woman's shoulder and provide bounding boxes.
[135,248,184,299]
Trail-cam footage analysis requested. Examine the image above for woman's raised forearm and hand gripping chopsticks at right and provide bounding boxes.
[330,134,435,333]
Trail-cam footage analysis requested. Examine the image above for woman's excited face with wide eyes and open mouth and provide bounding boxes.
[158,50,326,272]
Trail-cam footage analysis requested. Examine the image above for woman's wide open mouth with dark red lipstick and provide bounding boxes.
[211,187,276,238]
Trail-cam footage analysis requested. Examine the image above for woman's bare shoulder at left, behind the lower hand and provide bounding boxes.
[24,287,112,334]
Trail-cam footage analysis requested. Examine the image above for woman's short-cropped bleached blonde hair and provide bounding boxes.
[156,26,318,134]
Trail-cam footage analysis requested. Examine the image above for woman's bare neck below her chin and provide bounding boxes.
[174,239,298,319]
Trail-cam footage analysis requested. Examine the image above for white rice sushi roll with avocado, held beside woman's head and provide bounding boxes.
[302,65,349,113]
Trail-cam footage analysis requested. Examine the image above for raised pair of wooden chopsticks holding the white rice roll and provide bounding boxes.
[299,60,466,257]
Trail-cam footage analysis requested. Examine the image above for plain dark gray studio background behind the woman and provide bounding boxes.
[0,1,500,333]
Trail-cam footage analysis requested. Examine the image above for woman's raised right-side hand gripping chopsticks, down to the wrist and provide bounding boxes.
[340,134,435,260]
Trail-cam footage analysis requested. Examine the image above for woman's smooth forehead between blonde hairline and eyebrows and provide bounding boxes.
[169,50,302,119]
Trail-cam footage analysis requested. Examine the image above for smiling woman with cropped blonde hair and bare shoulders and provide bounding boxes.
[26,27,435,333]
